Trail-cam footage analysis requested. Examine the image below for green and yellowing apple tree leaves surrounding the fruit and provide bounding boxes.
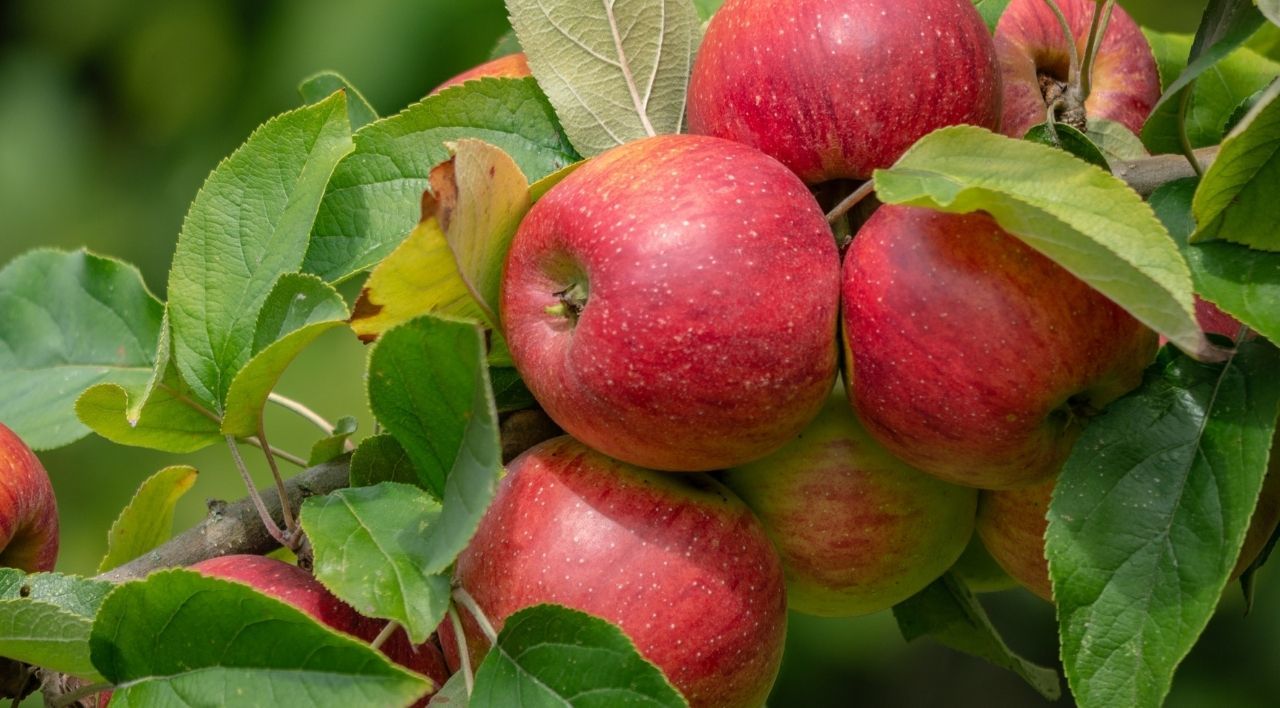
[0,0,1280,707]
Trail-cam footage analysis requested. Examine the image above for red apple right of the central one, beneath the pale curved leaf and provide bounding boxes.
[844,205,1157,489]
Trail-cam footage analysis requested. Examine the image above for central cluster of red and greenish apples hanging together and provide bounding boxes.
[417,0,1218,705]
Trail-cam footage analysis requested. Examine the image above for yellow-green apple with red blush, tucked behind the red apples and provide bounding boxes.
[721,381,978,617]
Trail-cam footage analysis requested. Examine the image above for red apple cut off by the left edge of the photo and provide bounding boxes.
[0,422,58,572]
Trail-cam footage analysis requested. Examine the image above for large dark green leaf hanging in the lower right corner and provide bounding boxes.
[1046,339,1280,707]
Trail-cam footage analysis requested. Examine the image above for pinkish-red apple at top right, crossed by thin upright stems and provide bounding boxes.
[996,0,1160,138]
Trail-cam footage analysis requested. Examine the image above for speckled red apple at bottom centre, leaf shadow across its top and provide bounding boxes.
[442,437,786,708]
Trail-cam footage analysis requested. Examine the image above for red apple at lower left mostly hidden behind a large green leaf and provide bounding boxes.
[191,556,449,688]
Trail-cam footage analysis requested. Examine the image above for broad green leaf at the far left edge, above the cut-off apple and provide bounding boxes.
[0,250,164,449]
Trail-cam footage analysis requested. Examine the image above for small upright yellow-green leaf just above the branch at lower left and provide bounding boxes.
[97,465,196,572]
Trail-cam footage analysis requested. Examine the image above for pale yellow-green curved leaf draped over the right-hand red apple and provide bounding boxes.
[874,125,1212,357]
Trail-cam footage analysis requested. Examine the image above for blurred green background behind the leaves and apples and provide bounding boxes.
[0,0,1280,707]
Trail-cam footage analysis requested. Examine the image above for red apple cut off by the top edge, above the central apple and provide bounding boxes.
[689,0,1000,184]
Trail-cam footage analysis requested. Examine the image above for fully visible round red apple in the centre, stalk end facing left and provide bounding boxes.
[500,136,840,471]
